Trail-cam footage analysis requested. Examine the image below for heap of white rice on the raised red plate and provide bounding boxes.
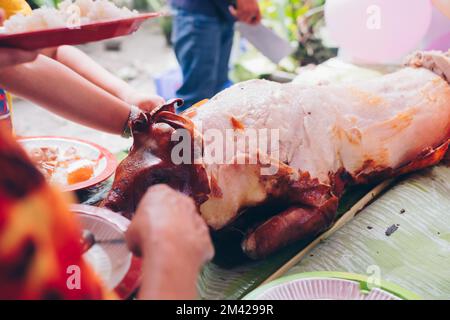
[3,0,138,33]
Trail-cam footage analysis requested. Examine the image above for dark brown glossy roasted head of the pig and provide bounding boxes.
[101,100,210,218]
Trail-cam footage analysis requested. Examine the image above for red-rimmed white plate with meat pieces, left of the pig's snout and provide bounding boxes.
[19,137,117,192]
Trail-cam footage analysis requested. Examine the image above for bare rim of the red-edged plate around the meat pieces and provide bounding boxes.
[18,137,117,192]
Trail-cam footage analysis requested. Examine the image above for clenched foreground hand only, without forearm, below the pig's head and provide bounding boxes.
[126,185,214,268]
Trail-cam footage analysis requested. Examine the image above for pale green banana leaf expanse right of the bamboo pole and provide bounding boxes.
[288,165,450,299]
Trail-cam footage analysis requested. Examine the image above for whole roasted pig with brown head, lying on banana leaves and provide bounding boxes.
[103,52,450,259]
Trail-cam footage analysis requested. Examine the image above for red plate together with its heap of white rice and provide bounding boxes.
[0,0,161,50]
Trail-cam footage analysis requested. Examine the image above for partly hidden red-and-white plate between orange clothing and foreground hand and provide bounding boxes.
[71,204,141,299]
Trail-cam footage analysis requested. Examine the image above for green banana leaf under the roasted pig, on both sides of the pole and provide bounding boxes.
[84,148,450,299]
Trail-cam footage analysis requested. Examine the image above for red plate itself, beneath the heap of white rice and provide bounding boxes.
[0,12,161,50]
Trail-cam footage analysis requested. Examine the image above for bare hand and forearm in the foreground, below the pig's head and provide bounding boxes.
[127,185,214,299]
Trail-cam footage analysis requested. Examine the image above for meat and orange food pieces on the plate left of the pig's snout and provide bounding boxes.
[28,147,97,185]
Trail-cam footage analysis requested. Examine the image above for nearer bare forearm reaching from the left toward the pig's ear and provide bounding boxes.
[0,55,130,134]
